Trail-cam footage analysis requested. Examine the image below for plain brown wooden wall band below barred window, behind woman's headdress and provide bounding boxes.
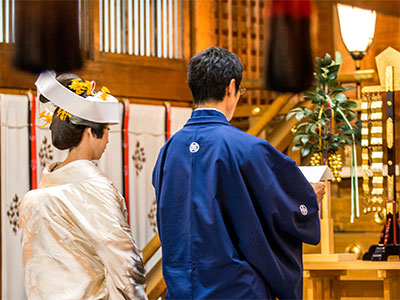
[0,47,192,106]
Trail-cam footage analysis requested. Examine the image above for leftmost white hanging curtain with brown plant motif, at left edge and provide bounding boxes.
[0,94,30,300]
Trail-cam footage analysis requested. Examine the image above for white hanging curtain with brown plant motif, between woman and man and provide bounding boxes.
[128,104,165,249]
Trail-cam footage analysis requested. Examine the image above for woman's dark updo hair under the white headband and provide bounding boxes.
[39,73,108,150]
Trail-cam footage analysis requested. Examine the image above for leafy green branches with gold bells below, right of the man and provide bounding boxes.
[286,51,361,182]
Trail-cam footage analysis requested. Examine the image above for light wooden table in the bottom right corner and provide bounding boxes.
[303,260,400,300]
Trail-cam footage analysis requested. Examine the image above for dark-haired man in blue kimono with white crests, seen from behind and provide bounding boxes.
[153,47,324,299]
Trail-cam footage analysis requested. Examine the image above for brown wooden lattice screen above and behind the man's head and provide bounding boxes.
[215,0,270,105]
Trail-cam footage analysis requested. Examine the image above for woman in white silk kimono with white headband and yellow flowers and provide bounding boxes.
[20,72,147,299]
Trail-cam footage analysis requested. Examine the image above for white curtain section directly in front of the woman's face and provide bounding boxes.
[98,103,123,194]
